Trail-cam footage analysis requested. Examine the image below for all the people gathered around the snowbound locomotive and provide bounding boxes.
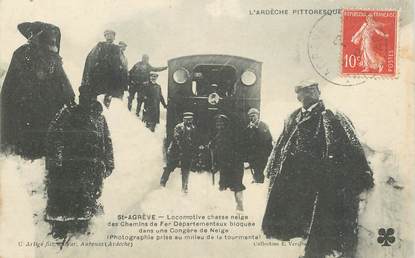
[1,22,374,258]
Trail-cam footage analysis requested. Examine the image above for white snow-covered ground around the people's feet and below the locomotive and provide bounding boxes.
[0,87,413,258]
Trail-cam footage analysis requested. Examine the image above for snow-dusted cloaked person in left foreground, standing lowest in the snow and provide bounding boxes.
[45,86,114,238]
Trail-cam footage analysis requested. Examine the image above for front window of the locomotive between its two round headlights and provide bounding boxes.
[192,65,236,97]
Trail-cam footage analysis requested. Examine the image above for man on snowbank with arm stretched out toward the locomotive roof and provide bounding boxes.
[128,55,167,116]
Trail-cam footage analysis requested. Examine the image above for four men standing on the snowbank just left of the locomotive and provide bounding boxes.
[82,30,167,132]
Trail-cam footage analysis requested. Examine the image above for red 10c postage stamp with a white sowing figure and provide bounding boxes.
[341,9,398,77]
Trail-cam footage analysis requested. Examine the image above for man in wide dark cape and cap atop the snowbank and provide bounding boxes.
[82,30,128,107]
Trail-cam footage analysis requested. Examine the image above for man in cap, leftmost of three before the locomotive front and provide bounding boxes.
[160,112,196,193]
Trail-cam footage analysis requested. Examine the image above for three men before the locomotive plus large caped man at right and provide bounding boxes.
[160,81,374,258]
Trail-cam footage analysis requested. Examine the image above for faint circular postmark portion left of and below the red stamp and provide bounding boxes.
[307,14,366,86]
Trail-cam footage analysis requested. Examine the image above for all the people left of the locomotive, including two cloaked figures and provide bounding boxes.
[1,22,166,238]
